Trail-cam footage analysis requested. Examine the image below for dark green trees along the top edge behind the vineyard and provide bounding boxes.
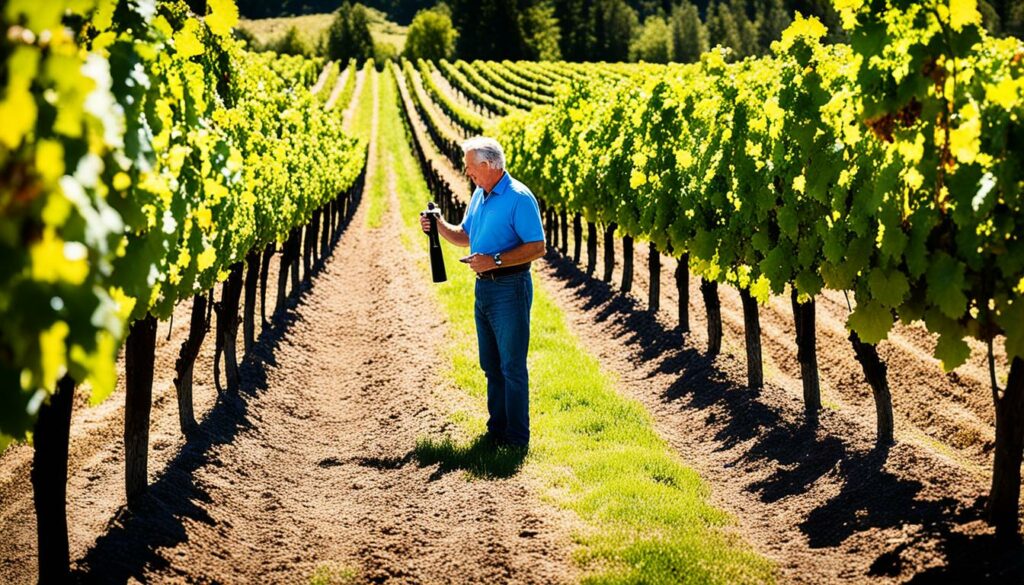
[239,0,1024,62]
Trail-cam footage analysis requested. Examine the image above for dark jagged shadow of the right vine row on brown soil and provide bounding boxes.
[545,249,1024,583]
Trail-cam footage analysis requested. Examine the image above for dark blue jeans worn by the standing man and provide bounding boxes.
[475,270,534,446]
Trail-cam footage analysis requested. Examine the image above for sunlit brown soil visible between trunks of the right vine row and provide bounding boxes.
[568,225,1008,471]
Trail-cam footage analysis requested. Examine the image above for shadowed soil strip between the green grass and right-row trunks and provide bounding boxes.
[538,253,1024,583]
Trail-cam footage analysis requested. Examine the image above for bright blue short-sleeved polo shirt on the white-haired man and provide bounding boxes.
[462,171,544,254]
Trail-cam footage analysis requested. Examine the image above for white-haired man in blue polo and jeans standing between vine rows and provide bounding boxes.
[420,136,545,448]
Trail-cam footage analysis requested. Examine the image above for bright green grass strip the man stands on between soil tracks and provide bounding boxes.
[378,65,775,583]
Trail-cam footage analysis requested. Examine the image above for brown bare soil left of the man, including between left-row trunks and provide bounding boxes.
[0,67,575,583]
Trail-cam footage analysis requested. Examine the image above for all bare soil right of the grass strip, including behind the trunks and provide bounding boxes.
[539,229,1024,583]
